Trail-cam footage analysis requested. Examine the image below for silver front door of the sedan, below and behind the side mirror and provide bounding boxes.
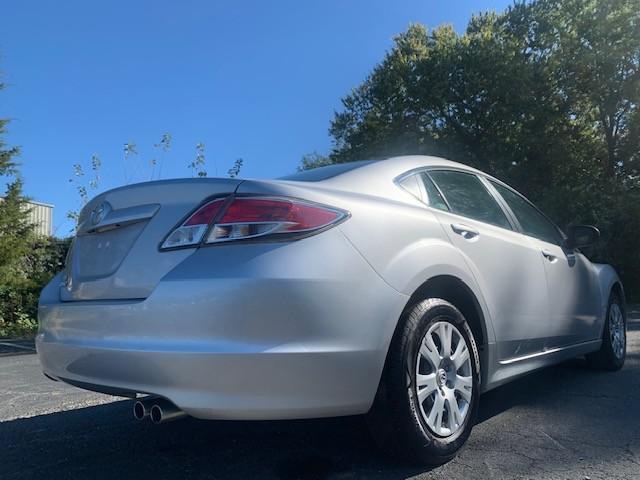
[489,180,600,348]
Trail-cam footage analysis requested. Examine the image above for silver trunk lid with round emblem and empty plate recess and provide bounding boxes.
[60,178,242,301]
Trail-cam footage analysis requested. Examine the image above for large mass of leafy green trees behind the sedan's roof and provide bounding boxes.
[314,0,640,294]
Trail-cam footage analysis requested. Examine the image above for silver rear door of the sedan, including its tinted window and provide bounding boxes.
[421,169,549,360]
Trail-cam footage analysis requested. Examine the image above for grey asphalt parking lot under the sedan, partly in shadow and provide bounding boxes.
[0,309,640,480]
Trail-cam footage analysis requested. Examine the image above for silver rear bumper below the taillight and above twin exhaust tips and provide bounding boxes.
[36,229,407,419]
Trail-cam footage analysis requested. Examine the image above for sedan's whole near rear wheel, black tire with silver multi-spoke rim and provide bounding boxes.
[367,299,480,465]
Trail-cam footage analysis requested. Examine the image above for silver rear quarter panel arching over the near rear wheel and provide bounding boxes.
[237,179,495,344]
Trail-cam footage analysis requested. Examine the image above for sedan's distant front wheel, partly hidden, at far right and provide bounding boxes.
[587,293,627,370]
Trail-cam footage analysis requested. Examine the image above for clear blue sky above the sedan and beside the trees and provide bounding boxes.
[0,0,511,235]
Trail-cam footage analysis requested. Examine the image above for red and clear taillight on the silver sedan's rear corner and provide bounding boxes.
[161,197,347,249]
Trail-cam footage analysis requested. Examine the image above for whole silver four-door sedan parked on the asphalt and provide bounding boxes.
[36,156,626,463]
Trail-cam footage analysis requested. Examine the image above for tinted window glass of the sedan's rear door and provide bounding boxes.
[429,170,511,230]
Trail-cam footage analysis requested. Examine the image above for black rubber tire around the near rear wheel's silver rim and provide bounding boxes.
[367,298,480,465]
